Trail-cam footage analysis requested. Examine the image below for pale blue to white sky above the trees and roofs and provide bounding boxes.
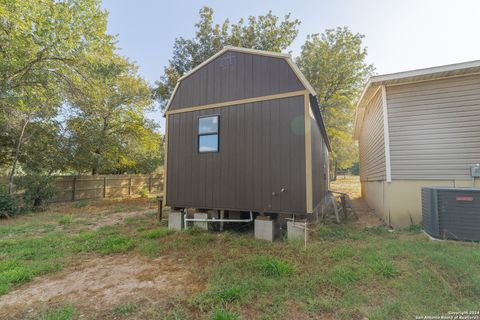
[102,0,480,132]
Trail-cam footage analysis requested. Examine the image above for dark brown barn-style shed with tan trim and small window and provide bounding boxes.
[164,47,330,214]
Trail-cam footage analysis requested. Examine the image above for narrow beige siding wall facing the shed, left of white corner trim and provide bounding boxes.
[358,90,386,181]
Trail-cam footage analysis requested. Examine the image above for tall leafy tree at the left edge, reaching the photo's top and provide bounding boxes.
[0,0,114,192]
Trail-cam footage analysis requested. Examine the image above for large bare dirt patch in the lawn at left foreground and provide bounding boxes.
[0,255,195,319]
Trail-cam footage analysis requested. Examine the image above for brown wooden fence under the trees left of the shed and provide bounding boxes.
[0,174,163,202]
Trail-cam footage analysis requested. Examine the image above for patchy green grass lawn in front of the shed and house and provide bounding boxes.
[0,184,480,319]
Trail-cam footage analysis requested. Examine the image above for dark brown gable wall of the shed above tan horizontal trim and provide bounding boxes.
[170,51,304,110]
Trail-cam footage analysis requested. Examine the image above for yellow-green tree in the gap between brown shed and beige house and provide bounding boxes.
[296,27,374,178]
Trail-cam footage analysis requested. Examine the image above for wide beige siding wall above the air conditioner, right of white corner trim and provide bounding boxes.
[387,75,480,180]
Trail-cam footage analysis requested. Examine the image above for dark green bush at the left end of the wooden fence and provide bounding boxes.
[16,173,55,211]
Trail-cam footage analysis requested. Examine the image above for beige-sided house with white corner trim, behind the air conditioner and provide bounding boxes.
[354,60,480,227]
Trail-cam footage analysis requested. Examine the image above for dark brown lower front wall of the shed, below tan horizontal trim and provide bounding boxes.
[167,95,306,213]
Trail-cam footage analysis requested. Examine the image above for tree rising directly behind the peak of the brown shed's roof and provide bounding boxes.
[155,7,300,108]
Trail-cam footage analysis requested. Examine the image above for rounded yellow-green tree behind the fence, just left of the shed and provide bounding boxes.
[67,54,161,174]
